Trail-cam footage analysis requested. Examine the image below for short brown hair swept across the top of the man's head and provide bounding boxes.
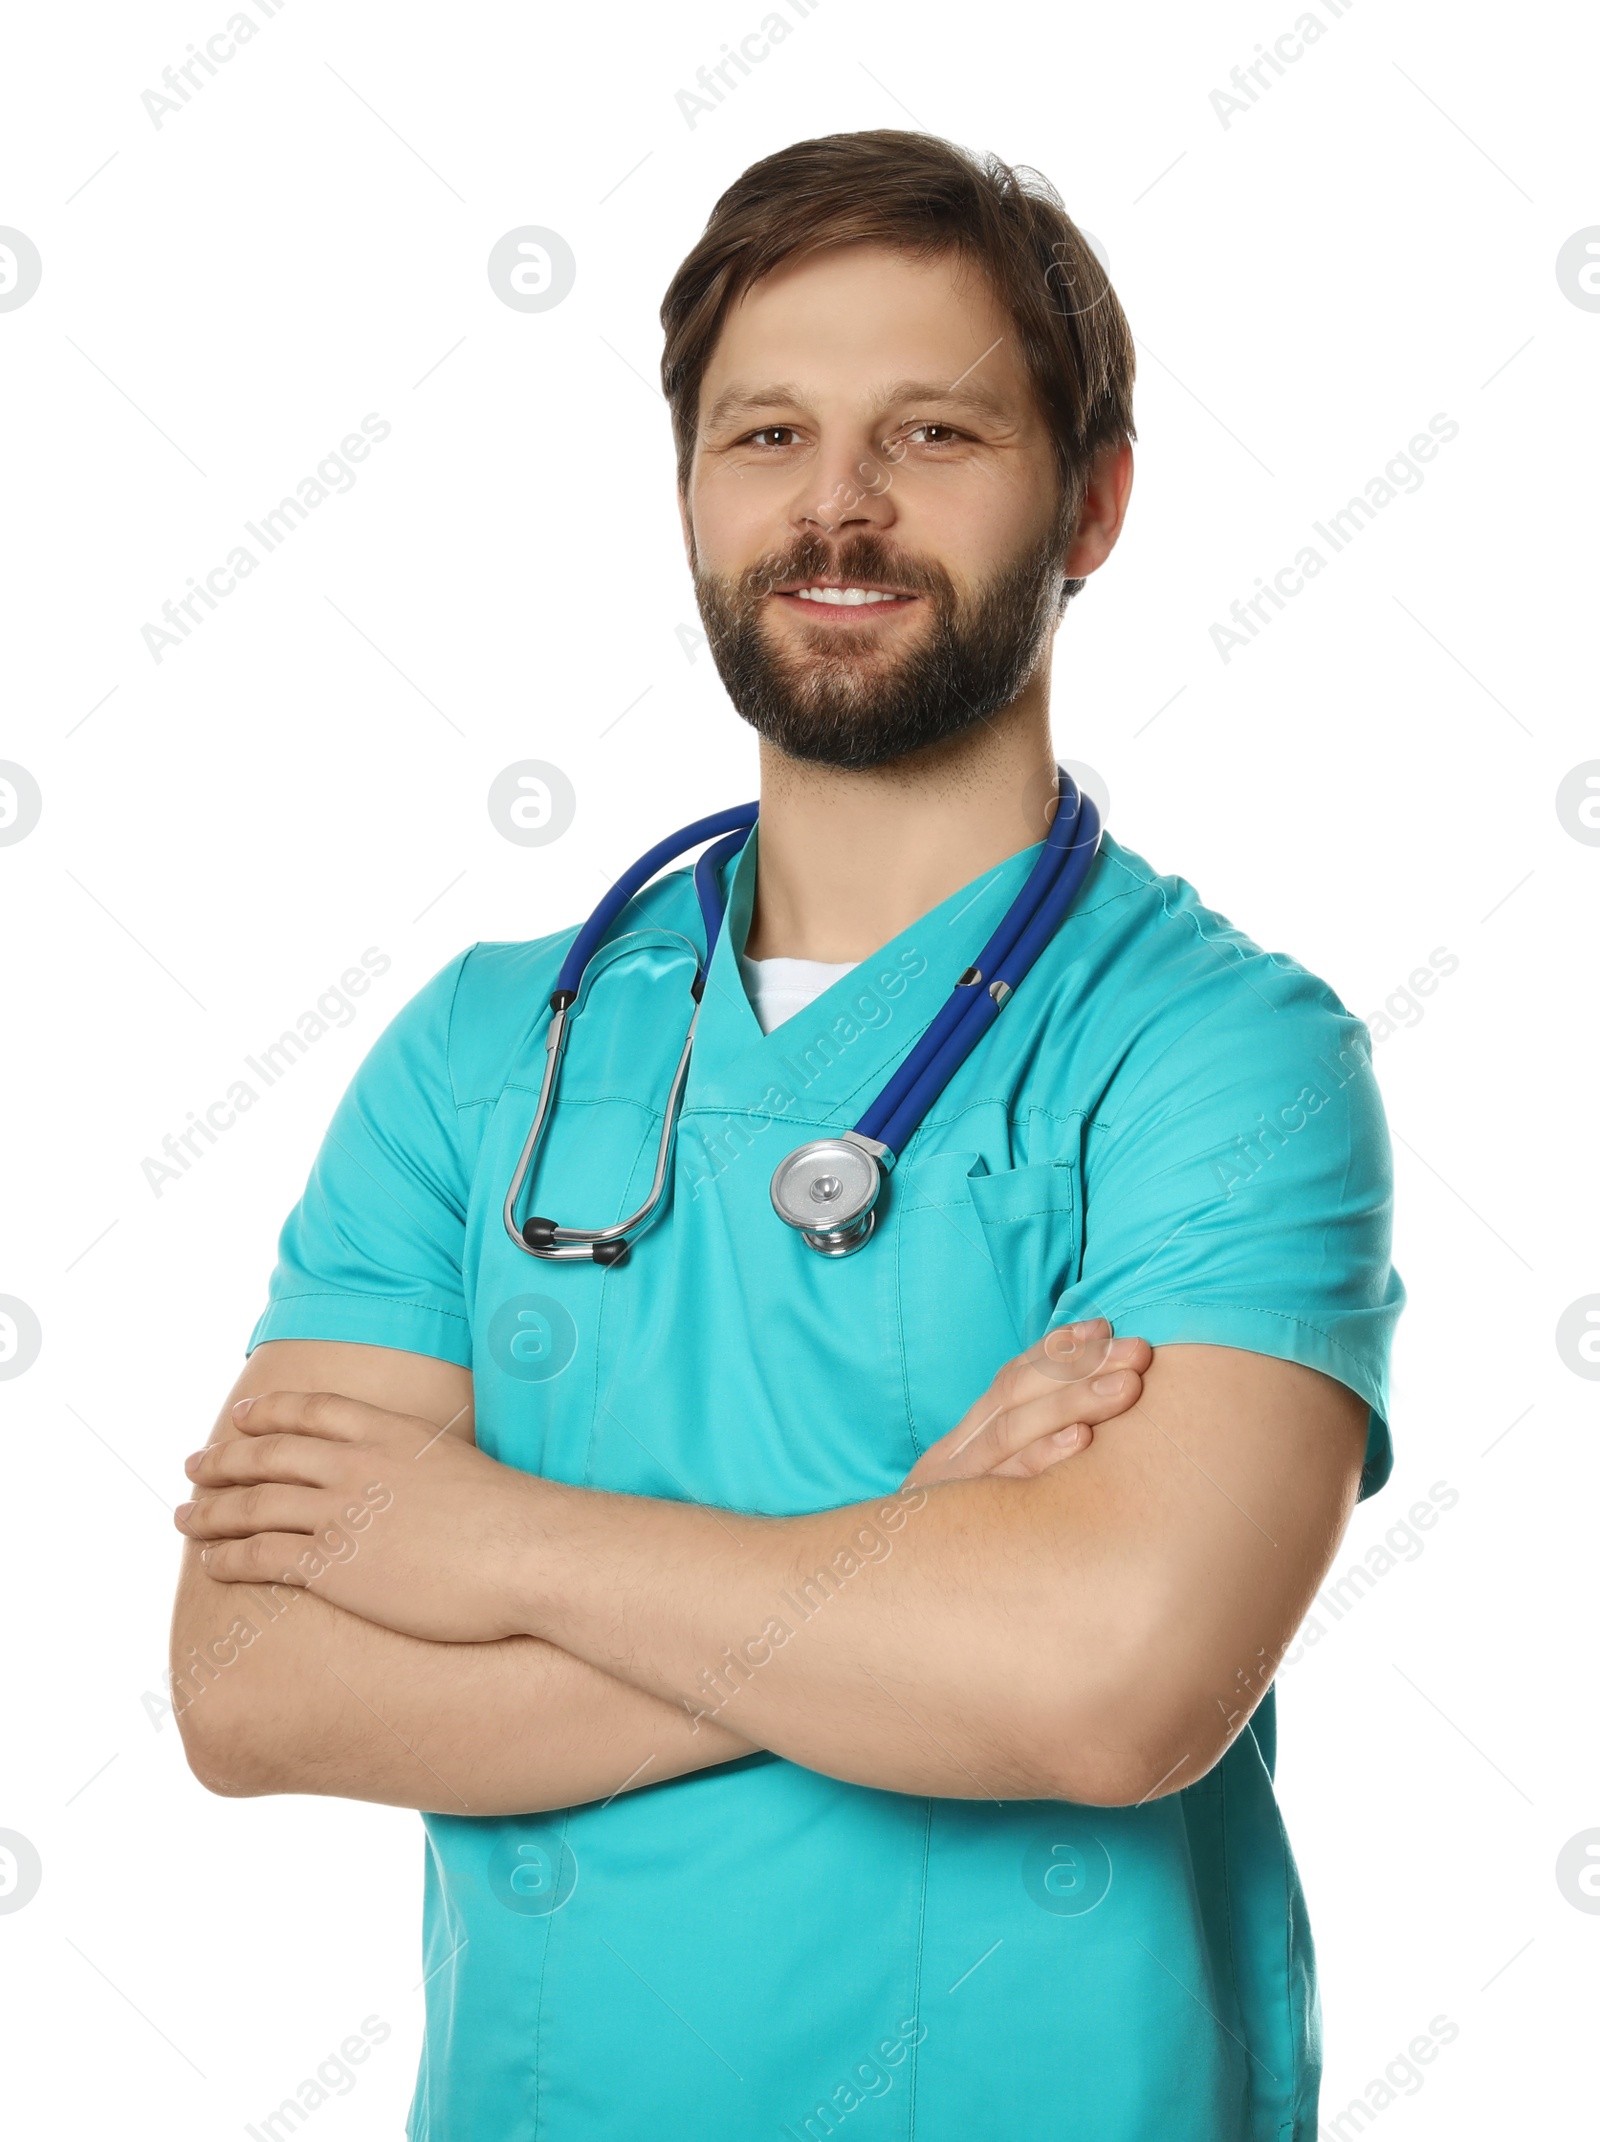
[662,129,1135,593]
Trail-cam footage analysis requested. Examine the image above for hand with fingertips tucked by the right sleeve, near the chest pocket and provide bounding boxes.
[906,1317,1152,1487]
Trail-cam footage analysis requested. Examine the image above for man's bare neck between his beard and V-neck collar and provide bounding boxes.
[745,692,1054,964]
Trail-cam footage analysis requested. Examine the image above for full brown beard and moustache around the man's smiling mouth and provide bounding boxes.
[694,514,1069,771]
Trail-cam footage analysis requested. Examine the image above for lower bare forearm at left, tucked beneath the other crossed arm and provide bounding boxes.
[171,1549,750,1814]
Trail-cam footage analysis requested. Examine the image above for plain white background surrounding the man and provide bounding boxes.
[0,0,1600,2142]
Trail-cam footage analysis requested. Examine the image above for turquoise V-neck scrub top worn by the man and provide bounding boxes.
[251,835,1405,2142]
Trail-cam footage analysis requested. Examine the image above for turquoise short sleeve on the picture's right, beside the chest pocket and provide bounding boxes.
[1052,955,1405,1495]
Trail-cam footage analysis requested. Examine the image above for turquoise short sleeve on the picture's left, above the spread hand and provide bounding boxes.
[246,949,471,1369]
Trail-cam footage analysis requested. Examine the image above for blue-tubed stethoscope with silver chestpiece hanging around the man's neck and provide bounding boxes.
[503,767,1101,1264]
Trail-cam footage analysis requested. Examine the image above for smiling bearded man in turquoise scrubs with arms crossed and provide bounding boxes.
[173,133,1403,2142]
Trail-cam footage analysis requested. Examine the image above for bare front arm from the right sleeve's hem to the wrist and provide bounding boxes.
[514,1345,1367,1804]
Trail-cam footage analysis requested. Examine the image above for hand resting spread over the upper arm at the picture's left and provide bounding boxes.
[176,1390,544,1643]
